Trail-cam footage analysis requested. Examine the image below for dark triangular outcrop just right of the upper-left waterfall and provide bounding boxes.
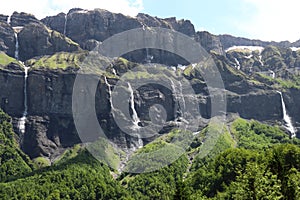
[18,23,80,60]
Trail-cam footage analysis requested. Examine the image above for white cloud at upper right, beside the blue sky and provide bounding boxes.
[238,0,300,42]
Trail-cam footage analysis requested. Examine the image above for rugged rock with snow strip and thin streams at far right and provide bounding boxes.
[226,46,300,79]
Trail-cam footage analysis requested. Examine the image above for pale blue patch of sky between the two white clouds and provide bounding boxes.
[143,0,255,38]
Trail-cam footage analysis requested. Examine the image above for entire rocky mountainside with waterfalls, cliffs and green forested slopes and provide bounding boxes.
[0,8,300,199]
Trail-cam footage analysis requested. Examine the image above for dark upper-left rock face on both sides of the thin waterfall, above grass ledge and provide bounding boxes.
[0,12,80,61]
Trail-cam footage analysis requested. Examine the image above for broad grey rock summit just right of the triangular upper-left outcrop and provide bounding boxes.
[42,9,142,45]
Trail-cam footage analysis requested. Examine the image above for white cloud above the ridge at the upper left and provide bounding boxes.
[0,0,143,19]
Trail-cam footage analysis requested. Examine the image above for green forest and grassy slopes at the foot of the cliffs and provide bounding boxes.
[0,108,300,200]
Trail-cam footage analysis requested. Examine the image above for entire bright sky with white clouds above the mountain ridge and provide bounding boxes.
[0,0,300,42]
